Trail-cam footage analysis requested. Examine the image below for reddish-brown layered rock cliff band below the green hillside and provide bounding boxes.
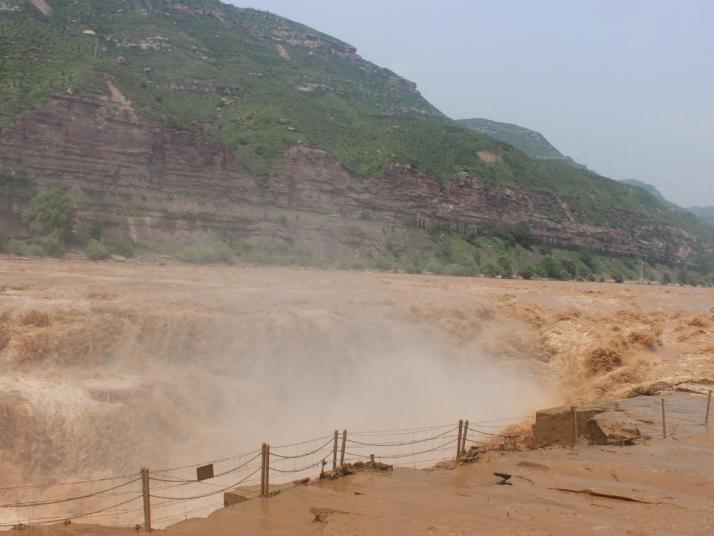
[0,97,695,261]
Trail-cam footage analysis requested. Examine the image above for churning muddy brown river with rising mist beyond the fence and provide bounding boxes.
[0,260,714,534]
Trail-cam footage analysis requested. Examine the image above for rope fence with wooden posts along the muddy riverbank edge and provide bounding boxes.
[0,392,711,532]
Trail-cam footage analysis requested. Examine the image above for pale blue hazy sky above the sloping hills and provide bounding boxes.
[233,0,714,206]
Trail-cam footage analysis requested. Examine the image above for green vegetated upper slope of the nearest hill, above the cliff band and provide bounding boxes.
[0,0,699,242]
